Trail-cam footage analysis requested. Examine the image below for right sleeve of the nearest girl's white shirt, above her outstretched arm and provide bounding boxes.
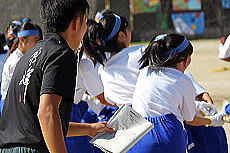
[180,76,196,121]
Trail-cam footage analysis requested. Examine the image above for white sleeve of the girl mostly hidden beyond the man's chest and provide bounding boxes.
[79,59,104,97]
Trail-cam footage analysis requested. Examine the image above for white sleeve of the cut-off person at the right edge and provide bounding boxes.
[218,35,230,59]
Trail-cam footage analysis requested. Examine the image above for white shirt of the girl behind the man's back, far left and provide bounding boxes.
[1,48,23,100]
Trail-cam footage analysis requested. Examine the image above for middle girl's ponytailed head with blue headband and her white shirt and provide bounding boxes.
[83,14,145,106]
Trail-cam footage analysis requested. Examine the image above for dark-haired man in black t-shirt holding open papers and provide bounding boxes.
[0,0,113,153]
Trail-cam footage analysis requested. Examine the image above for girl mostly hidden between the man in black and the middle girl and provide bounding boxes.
[65,20,117,153]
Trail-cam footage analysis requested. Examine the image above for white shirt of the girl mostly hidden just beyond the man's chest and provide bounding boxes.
[74,55,104,104]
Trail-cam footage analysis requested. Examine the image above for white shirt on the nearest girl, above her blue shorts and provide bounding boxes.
[132,67,196,122]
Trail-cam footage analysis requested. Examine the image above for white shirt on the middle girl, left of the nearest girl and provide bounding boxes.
[99,46,145,105]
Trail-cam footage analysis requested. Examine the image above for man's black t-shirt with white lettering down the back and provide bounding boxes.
[0,33,76,149]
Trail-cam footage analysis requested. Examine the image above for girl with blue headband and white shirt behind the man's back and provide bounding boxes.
[1,22,41,100]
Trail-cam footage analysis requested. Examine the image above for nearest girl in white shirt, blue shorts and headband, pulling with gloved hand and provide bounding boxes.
[129,34,226,153]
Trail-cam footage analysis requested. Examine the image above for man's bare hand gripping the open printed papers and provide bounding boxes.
[89,121,116,137]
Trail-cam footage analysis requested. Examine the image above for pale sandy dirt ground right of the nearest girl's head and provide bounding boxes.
[185,39,230,153]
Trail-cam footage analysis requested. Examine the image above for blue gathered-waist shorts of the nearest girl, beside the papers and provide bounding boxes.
[128,114,186,153]
